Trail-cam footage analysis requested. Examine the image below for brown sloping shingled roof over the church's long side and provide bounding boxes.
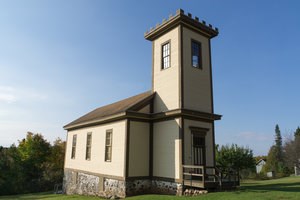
[64,91,155,130]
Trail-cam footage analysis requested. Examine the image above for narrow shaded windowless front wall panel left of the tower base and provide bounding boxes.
[129,121,150,177]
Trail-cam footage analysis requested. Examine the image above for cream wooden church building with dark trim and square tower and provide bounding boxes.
[64,9,221,198]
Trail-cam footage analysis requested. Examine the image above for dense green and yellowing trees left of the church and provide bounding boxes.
[0,132,65,195]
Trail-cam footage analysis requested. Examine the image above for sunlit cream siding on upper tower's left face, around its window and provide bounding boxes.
[153,27,179,112]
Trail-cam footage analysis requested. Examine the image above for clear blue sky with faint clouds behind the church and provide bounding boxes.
[0,0,300,155]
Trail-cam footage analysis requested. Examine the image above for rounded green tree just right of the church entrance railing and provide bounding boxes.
[216,144,255,175]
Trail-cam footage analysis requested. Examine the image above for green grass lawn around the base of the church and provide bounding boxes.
[0,177,300,200]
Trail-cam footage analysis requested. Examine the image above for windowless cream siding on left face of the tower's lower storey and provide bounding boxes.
[153,120,180,179]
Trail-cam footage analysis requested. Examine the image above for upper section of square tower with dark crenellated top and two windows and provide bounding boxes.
[145,9,218,114]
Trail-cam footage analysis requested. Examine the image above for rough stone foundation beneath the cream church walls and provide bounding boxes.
[63,170,182,198]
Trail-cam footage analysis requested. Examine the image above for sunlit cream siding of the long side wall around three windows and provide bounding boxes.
[65,121,126,177]
